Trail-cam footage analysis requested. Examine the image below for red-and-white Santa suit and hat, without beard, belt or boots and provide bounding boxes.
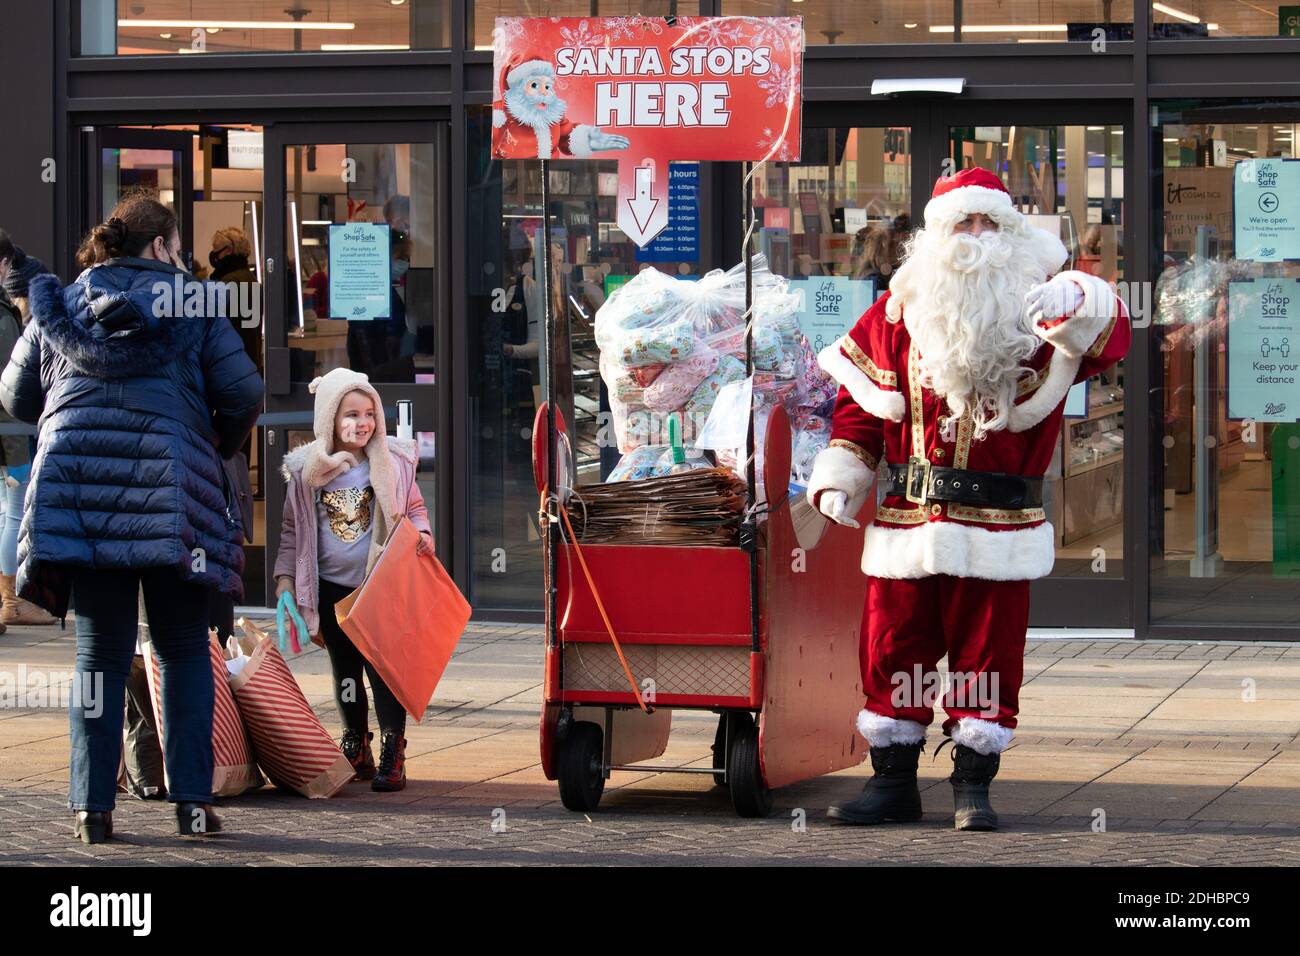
[809,170,1130,753]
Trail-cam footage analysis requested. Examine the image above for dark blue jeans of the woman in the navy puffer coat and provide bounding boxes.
[68,567,213,810]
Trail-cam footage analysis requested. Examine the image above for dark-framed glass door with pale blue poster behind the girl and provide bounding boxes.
[264,122,450,598]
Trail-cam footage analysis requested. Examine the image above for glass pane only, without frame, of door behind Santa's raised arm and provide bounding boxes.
[949,126,1125,578]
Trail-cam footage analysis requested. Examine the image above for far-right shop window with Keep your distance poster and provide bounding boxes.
[1151,101,1300,627]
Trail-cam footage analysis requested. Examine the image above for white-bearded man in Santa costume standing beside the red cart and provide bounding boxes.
[809,169,1130,830]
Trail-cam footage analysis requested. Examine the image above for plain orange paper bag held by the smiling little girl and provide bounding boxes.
[334,518,469,721]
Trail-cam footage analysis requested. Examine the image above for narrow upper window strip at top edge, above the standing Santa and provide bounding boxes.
[722,0,1134,46]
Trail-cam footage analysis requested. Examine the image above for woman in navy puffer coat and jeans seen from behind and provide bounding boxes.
[0,195,263,843]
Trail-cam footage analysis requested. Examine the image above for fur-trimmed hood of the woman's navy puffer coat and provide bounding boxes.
[30,259,211,378]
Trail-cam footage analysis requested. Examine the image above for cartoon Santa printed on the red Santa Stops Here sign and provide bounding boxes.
[491,53,628,159]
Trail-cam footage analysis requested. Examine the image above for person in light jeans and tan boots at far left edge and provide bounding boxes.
[0,229,55,633]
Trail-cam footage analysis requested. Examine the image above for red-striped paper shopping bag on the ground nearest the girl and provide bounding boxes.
[230,622,355,797]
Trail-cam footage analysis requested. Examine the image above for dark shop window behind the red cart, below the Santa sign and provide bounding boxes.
[465,107,709,610]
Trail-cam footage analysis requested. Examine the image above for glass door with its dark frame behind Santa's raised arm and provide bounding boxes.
[917,103,1141,627]
